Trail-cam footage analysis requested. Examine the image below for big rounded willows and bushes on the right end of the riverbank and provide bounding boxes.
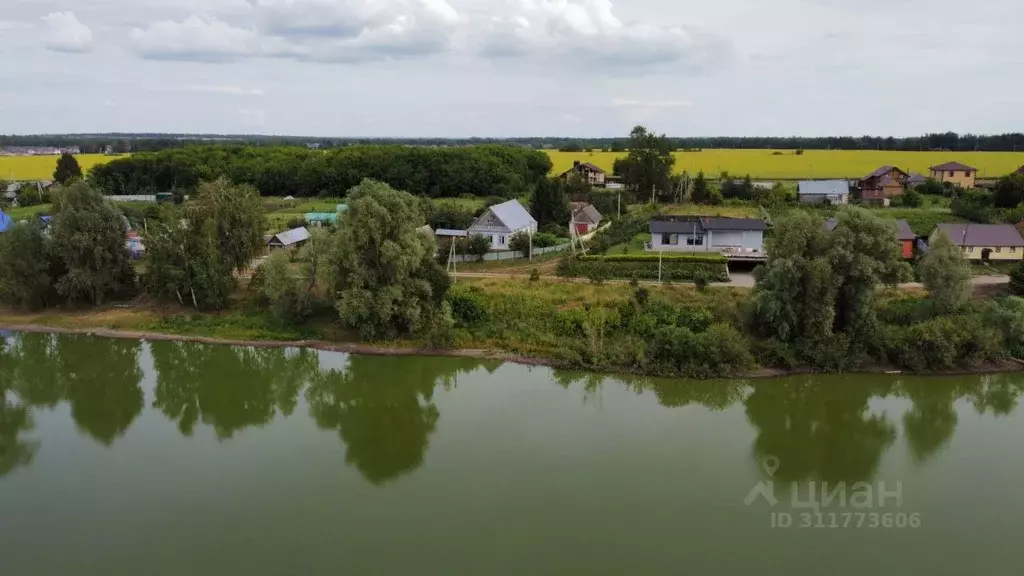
[752,207,1024,370]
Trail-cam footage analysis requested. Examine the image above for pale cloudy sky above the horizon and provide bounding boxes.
[0,0,1024,136]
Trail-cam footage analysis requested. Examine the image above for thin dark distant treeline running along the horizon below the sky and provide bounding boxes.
[6,132,1024,154]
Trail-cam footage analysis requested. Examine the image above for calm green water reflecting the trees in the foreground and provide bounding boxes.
[0,334,1024,576]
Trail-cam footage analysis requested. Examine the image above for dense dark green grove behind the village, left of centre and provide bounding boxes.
[88,146,551,198]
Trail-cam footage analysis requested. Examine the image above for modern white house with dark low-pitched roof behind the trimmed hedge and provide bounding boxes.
[646,216,767,257]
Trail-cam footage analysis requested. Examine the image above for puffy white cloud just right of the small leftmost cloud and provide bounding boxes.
[130,15,261,61]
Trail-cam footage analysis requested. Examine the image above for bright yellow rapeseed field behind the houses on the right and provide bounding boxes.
[548,150,1024,179]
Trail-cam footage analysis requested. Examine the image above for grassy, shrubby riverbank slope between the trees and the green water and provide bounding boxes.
[0,279,1024,378]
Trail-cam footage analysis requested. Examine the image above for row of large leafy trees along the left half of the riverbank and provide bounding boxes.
[0,179,451,343]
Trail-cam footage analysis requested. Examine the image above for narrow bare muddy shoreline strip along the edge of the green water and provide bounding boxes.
[0,320,1024,380]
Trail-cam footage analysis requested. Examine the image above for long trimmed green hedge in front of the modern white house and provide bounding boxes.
[558,256,729,282]
